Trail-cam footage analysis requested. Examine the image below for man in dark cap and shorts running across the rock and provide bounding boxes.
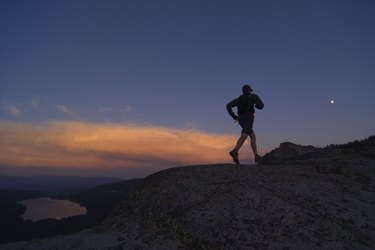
[227,85,264,164]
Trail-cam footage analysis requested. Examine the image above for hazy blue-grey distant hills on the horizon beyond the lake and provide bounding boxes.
[0,175,122,192]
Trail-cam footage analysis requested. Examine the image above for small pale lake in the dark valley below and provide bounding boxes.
[19,197,87,221]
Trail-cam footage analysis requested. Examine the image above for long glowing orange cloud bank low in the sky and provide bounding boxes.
[0,121,236,173]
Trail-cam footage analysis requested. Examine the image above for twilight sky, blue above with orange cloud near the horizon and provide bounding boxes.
[0,0,375,178]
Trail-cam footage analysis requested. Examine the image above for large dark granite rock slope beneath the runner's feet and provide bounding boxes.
[0,145,375,249]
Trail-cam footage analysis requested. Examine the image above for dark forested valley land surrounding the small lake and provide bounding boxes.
[0,180,140,244]
